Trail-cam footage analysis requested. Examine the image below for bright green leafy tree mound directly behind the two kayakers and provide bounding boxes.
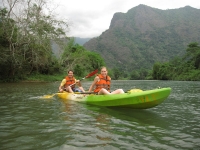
[61,38,105,76]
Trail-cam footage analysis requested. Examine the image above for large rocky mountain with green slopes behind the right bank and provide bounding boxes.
[83,5,200,71]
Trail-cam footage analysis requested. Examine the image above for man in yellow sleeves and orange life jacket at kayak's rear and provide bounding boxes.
[59,70,85,93]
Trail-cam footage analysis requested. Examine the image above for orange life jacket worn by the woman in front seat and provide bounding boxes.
[94,74,111,93]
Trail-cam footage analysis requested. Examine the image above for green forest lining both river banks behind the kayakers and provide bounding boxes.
[0,0,200,82]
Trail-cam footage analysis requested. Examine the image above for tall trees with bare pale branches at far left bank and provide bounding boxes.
[0,0,68,79]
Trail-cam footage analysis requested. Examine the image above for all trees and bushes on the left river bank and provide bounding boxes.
[0,0,104,82]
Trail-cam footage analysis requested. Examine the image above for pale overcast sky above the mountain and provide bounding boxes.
[53,0,200,38]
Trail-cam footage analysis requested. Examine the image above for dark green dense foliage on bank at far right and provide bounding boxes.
[152,42,200,81]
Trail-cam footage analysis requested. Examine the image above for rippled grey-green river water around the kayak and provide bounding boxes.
[0,80,200,150]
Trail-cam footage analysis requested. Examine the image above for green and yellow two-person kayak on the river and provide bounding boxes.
[57,88,171,109]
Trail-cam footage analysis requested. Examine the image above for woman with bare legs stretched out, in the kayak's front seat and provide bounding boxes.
[89,67,124,95]
